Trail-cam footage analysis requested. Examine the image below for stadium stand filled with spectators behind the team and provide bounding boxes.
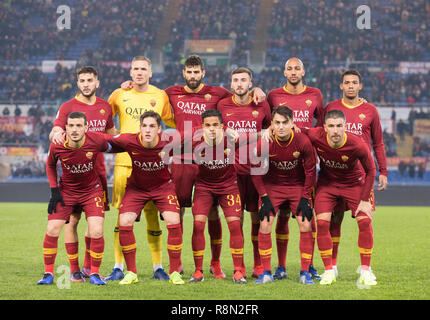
[0,0,430,183]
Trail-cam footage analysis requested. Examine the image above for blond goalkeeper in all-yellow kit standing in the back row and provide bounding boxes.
[106,56,175,281]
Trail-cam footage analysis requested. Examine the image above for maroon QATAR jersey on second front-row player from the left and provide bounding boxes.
[106,133,173,191]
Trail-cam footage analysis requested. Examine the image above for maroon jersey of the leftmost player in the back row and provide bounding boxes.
[54,97,114,132]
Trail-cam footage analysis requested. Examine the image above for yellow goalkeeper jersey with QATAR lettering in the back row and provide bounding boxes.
[108,85,176,167]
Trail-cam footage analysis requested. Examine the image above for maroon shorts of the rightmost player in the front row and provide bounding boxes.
[315,184,373,217]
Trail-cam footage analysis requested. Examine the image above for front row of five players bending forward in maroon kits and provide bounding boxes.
[38,105,377,286]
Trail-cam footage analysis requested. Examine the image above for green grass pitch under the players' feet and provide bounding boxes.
[0,203,430,300]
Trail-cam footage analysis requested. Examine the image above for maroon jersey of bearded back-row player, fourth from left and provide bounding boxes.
[217,96,272,174]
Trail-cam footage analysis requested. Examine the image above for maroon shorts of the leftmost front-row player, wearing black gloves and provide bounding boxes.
[48,190,105,223]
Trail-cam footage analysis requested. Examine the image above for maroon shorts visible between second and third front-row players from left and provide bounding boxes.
[170,163,199,207]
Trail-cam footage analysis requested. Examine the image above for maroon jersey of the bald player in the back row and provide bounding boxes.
[267,85,324,128]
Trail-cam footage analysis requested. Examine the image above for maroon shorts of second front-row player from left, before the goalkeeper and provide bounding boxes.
[119,181,180,221]
